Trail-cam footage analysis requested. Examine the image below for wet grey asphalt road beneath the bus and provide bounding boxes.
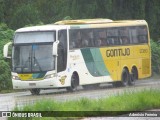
[0,79,160,111]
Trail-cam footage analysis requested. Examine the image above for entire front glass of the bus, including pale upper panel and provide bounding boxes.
[12,31,55,73]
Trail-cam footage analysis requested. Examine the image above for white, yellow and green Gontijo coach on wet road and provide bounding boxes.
[3,19,151,94]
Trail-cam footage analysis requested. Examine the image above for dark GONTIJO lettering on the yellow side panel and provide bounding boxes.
[106,48,130,57]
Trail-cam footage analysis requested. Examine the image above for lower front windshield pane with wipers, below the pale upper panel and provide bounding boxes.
[12,43,55,73]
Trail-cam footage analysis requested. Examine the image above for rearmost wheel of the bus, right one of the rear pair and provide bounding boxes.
[128,68,138,86]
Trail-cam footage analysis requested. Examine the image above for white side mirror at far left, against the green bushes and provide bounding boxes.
[3,42,12,58]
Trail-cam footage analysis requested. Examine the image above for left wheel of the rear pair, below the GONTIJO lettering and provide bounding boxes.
[121,69,130,87]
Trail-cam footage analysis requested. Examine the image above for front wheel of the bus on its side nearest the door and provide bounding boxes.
[66,73,79,92]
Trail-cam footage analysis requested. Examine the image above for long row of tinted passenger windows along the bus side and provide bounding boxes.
[70,26,148,49]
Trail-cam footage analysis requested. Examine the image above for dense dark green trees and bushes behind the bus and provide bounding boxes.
[0,0,160,90]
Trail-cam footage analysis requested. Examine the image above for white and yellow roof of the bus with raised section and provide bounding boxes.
[16,19,147,32]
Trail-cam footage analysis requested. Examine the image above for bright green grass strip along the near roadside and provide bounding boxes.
[10,89,160,120]
